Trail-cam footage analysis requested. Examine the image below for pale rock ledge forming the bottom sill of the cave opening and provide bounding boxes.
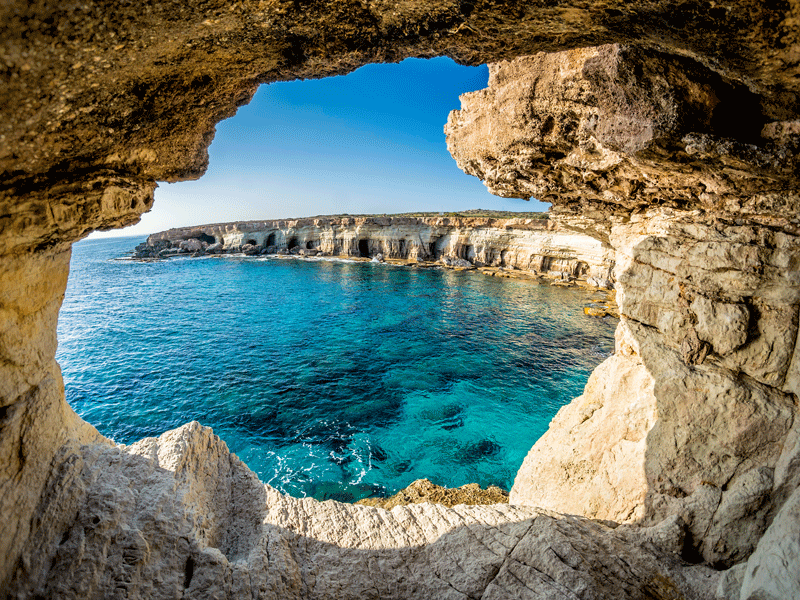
[7,423,717,600]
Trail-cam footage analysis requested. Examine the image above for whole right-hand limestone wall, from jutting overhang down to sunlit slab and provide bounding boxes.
[446,46,800,584]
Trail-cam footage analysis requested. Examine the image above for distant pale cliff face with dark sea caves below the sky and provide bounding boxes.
[141,216,614,286]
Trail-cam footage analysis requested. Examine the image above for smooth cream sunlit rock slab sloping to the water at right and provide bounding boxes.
[509,354,657,521]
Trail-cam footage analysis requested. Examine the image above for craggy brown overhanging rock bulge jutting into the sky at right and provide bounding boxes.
[445,45,800,223]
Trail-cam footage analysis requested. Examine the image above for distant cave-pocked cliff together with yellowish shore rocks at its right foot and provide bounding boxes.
[132,212,619,318]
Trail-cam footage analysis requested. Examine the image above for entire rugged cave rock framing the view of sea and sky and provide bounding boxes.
[0,0,800,600]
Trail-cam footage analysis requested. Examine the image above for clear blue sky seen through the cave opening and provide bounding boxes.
[93,58,548,237]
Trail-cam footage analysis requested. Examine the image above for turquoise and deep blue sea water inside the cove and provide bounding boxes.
[57,238,616,501]
